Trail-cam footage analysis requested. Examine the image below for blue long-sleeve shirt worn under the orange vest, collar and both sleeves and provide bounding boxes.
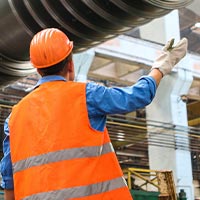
[0,75,156,189]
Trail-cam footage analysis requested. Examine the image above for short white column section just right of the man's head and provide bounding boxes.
[73,49,95,82]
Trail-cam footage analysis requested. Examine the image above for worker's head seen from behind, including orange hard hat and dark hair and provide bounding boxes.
[30,28,74,80]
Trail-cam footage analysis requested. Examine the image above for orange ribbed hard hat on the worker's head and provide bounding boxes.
[30,28,73,68]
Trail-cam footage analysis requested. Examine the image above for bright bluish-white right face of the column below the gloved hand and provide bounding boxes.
[170,57,194,200]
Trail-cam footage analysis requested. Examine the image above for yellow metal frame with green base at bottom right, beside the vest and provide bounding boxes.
[123,168,186,200]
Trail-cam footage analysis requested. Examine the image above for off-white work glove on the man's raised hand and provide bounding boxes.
[151,38,188,76]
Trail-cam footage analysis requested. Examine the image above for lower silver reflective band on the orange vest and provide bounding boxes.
[22,177,126,200]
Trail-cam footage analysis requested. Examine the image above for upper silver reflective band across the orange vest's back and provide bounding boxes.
[13,142,113,173]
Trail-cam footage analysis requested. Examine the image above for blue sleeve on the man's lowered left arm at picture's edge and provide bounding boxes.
[0,115,14,189]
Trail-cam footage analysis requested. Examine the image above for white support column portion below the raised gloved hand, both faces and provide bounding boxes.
[146,58,194,200]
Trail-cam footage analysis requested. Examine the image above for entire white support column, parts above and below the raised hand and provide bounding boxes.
[141,11,194,200]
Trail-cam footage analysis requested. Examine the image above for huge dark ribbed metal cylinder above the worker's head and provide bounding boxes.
[0,0,192,86]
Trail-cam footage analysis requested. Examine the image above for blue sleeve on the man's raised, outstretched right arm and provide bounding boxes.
[86,76,156,115]
